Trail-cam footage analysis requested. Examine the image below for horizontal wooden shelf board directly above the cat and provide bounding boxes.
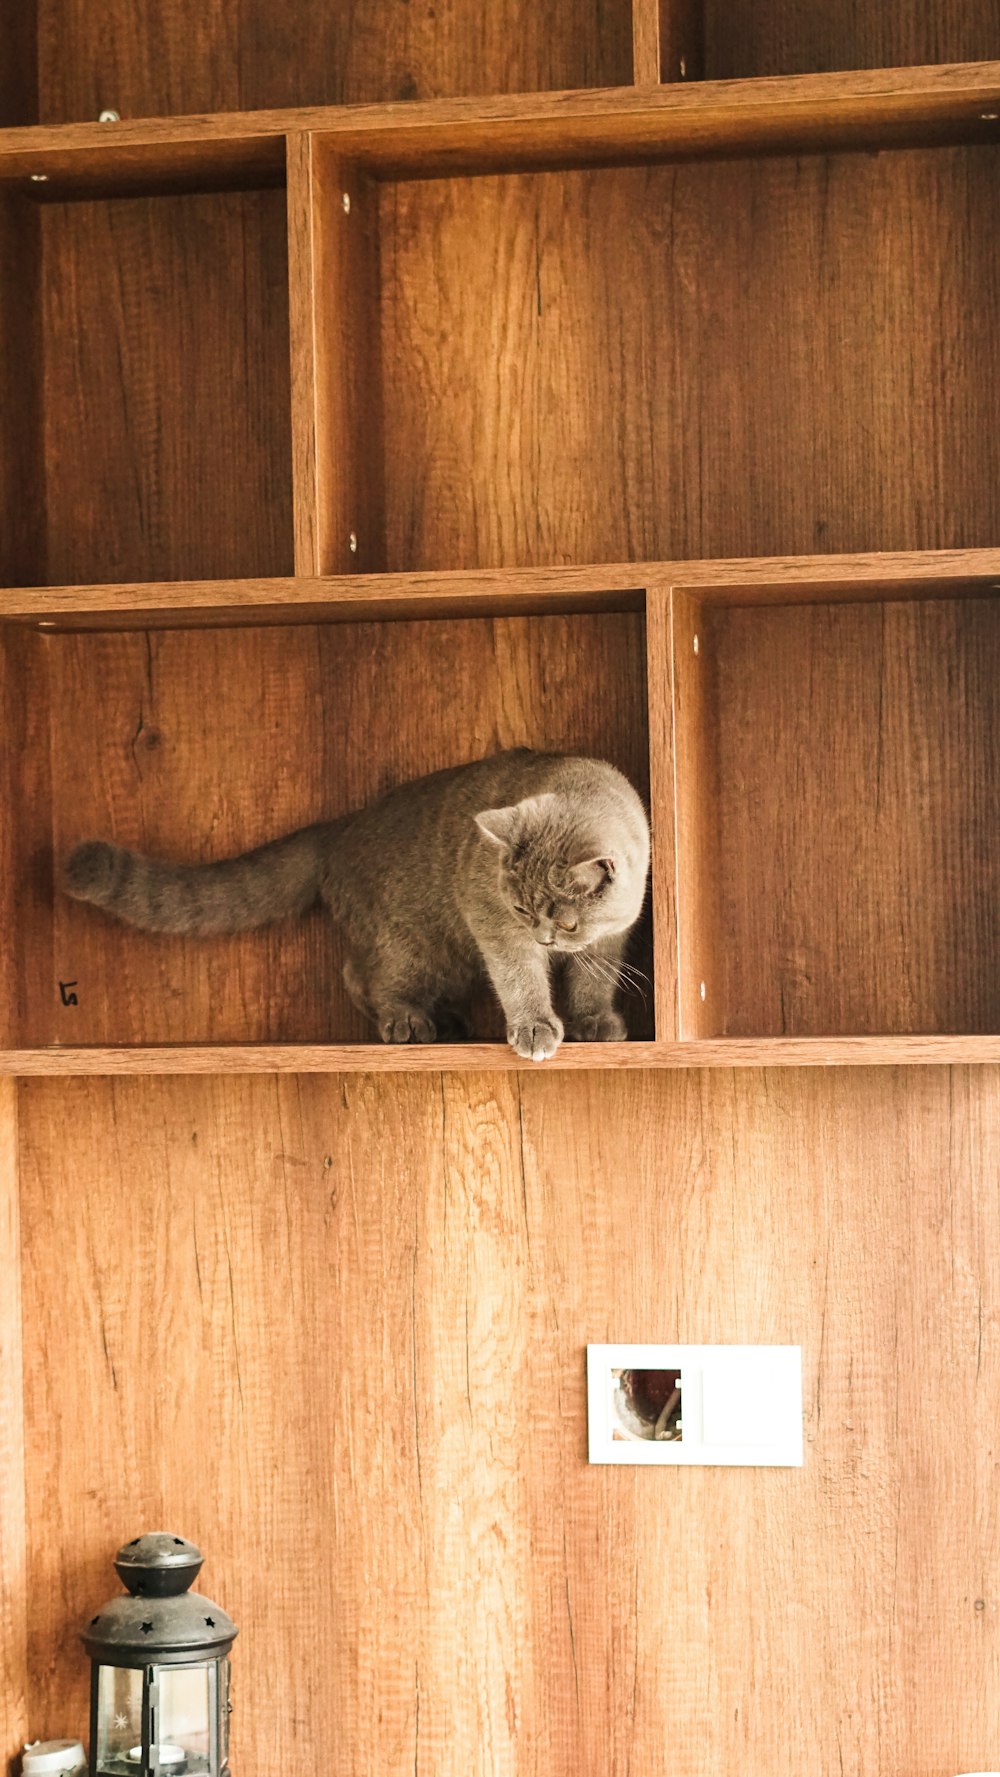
[0,549,1000,629]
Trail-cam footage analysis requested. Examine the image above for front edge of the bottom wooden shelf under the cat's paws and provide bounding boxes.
[0,1034,1000,1079]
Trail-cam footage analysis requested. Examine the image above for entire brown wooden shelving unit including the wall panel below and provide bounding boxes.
[0,31,1000,1777]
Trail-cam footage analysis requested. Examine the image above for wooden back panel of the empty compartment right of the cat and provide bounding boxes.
[699,601,1000,1036]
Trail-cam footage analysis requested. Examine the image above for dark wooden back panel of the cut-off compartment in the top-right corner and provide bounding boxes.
[703,0,1000,80]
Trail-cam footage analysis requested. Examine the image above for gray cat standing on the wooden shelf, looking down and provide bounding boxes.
[64,748,650,1061]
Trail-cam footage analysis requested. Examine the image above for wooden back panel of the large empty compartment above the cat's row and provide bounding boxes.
[382,149,1000,570]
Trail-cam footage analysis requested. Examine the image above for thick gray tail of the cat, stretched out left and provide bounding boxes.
[62,821,343,936]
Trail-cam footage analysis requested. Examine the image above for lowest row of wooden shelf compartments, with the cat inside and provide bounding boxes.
[0,551,1000,1073]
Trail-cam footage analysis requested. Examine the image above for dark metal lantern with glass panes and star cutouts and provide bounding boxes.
[80,1530,236,1777]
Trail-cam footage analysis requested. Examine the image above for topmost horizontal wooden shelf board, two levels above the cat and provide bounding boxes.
[0,60,1000,197]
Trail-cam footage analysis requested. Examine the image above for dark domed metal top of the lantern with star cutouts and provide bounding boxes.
[82,1530,236,1667]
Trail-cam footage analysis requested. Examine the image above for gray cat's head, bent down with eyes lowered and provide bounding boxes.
[476,793,647,951]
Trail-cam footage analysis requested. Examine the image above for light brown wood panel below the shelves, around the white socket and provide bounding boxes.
[20,1068,1000,1777]
